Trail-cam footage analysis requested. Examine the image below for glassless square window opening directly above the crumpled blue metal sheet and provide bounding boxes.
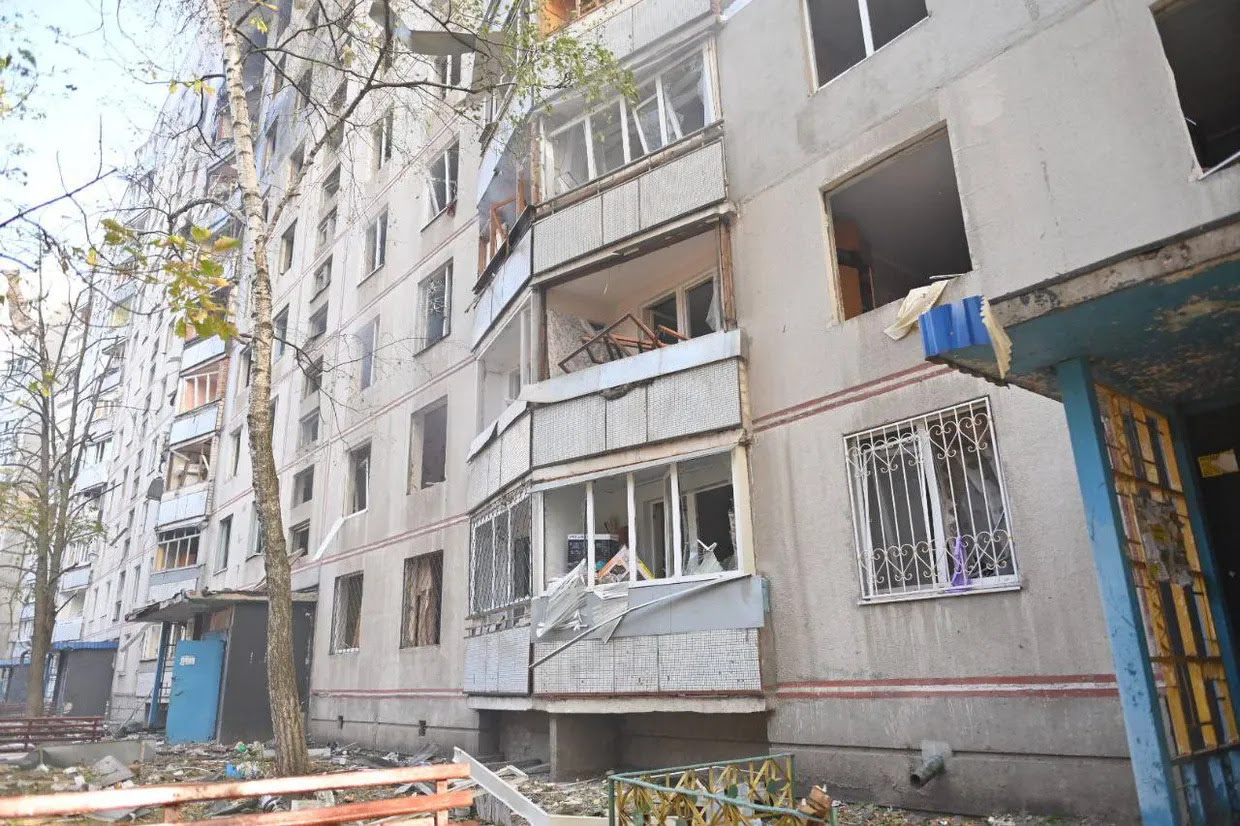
[826,133,973,319]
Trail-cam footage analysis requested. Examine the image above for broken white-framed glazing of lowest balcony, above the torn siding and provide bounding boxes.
[542,453,739,587]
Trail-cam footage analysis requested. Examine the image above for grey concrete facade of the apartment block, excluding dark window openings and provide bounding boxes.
[79,0,1240,822]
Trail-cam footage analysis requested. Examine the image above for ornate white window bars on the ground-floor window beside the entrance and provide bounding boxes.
[844,398,1019,602]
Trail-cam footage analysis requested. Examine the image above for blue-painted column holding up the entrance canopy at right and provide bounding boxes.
[1056,358,1182,826]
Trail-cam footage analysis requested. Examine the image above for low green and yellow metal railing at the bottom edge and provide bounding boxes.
[609,753,817,826]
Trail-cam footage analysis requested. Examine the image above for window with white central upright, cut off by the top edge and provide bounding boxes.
[806,0,926,86]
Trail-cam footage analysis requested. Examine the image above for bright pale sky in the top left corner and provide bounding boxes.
[0,0,185,265]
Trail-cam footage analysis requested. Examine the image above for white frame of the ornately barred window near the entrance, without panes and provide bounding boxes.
[844,397,1021,604]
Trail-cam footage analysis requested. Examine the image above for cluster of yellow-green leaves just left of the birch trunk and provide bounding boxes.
[96,218,241,340]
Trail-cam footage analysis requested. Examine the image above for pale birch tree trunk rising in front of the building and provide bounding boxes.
[208,0,310,775]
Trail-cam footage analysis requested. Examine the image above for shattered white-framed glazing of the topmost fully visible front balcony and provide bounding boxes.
[543,51,715,195]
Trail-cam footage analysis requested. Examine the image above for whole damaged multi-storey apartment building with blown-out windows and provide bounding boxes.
[72,0,1240,822]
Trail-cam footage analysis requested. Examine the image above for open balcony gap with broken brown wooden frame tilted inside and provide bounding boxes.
[546,232,724,376]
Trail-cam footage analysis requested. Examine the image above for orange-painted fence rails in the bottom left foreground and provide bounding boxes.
[0,763,474,826]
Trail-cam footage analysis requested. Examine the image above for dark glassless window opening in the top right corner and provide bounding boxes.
[1154,0,1240,171]
